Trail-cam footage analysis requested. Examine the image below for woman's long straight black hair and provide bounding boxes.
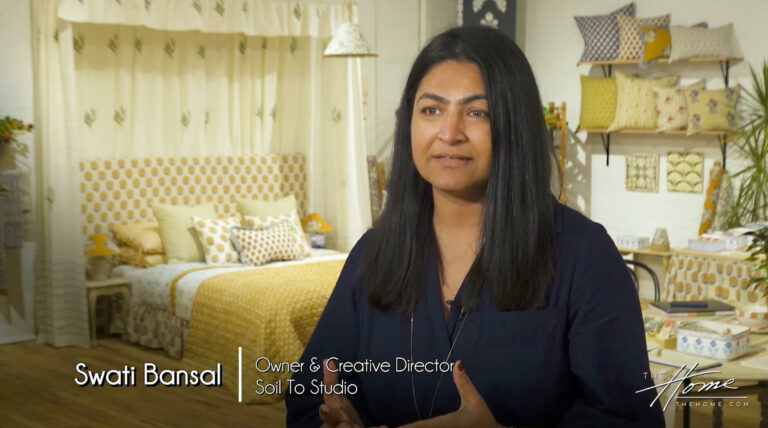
[361,26,556,312]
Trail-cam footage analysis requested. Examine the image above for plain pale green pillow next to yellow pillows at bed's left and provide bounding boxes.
[152,204,216,263]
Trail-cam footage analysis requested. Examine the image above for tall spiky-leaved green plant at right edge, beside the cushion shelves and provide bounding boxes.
[726,61,768,228]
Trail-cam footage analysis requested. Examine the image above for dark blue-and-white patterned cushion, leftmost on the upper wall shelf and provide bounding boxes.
[573,2,635,61]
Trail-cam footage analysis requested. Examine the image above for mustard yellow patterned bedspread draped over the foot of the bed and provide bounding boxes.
[182,260,344,403]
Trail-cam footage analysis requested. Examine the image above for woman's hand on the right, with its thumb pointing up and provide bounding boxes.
[401,360,508,428]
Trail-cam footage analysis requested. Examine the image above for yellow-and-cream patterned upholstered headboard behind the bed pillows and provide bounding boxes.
[80,154,307,235]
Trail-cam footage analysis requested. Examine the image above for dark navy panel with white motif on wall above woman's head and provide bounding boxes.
[457,0,517,40]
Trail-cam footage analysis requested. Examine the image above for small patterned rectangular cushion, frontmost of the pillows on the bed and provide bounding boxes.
[231,220,302,266]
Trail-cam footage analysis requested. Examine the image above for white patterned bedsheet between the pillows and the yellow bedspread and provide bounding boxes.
[112,249,347,321]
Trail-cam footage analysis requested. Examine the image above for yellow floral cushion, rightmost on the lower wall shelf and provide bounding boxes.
[685,86,739,135]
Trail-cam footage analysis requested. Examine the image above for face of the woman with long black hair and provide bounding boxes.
[411,60,491,200]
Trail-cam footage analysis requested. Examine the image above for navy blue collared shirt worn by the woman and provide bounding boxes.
[286,205,664,428]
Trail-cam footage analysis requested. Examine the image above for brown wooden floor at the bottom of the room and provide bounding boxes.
[0,338,760,428]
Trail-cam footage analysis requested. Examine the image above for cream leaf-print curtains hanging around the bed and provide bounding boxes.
[32,0,370,344]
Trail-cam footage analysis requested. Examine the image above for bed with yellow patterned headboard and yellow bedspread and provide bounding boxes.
[80,154,346,403]
